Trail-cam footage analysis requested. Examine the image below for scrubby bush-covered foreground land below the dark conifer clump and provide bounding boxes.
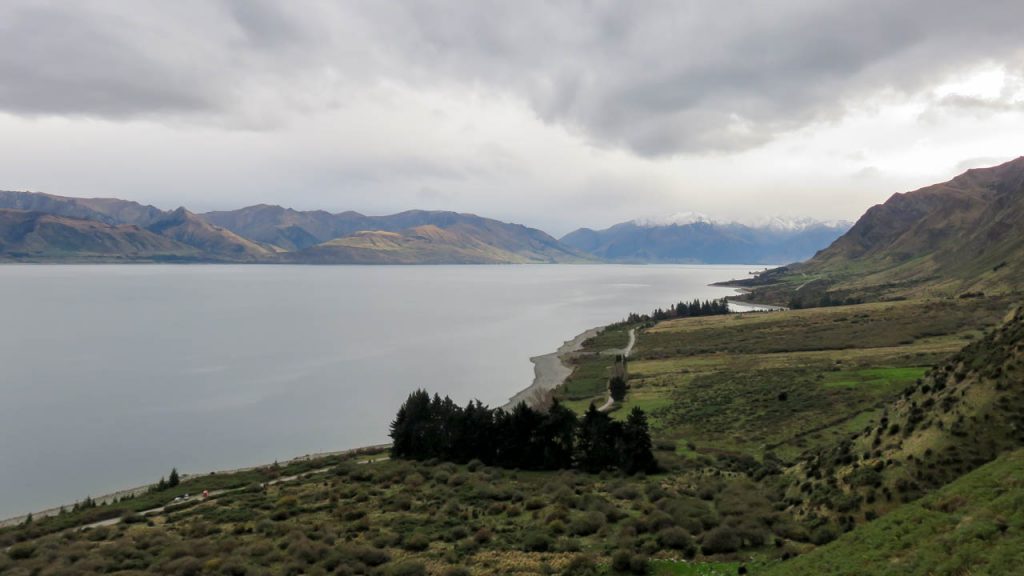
[0,448,784,574]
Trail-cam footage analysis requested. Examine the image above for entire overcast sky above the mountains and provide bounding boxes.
[0,0,1024,236]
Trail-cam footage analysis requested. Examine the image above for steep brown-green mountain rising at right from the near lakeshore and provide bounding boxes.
[737,157,1024,305]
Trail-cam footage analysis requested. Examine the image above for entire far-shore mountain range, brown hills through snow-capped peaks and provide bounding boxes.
[0,192,845,264]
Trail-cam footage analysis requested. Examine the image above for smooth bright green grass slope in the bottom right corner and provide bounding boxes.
[764,450,1024,576]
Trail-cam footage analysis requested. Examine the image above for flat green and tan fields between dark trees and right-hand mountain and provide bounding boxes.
[561,297,1013,461]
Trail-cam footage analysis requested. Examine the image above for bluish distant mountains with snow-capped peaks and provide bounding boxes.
[561,212,849,263]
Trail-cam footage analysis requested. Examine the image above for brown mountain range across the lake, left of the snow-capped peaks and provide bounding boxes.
[0,192,592,264]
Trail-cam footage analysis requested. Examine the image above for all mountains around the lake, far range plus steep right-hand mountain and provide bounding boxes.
[6,157,1024,268]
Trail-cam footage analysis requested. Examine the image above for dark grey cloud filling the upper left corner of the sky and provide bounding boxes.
[0,3,217,117]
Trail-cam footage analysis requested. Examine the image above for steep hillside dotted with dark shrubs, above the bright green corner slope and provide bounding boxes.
[787,308,1024,523]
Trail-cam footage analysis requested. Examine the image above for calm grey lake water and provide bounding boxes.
[0,265,763,519]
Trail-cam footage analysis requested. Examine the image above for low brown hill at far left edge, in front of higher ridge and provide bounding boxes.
[0,209,202,261]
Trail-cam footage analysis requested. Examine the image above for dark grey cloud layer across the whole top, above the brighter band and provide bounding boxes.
[0,0,1024,156]
